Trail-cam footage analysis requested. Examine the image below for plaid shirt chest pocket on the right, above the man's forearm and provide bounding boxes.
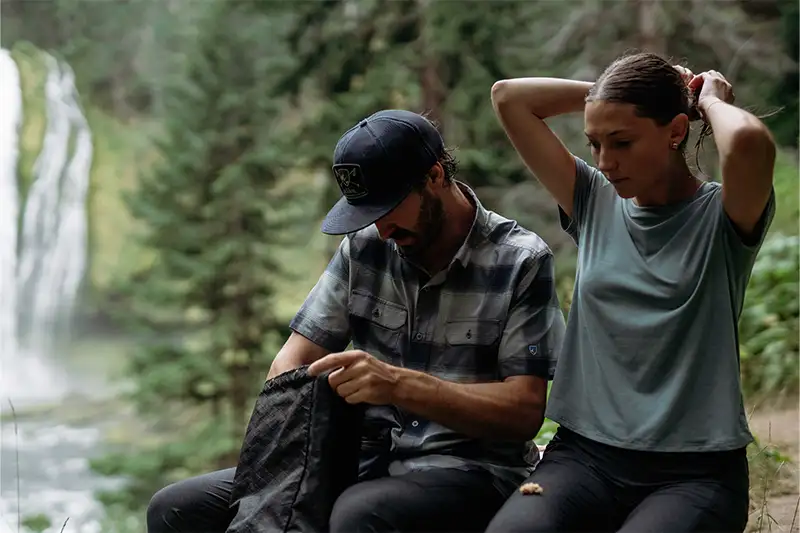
[437,319,502,382]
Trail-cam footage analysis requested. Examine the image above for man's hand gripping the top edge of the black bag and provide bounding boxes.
[308,350,400,405]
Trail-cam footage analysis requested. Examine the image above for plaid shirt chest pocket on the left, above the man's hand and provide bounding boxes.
[350,291,408,363]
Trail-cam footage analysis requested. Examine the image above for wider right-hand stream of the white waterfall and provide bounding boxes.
[18,56,92,358]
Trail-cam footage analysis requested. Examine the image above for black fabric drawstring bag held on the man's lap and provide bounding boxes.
[226,366,364,533]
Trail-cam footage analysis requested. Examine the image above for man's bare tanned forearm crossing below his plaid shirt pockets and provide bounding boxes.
[394,369,544,440]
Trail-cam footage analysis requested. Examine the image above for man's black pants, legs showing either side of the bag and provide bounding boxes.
[147,468,508,533]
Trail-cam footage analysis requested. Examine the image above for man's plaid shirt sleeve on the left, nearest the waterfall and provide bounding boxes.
[289,237,351,352]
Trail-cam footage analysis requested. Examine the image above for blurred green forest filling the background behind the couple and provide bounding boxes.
[3,0,799,531]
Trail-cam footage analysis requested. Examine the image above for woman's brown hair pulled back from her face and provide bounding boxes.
[586,52,711,170]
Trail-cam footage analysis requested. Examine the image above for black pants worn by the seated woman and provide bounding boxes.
[487,427,749,533]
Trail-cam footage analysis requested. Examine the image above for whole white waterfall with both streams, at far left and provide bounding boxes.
[0,50,93,408]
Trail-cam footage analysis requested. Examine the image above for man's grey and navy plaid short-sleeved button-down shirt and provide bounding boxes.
[291,183,565,486]
